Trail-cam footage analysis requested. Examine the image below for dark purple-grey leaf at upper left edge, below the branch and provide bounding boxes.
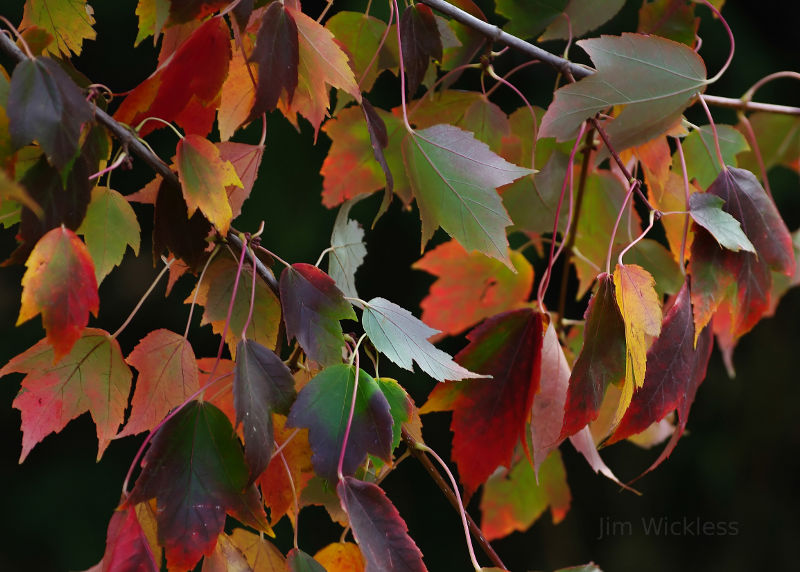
[7,58,92,170]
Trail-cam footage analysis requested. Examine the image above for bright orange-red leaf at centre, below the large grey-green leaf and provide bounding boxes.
[412,240,533,335]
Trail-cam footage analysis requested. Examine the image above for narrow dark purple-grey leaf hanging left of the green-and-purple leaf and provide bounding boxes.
[233,339,296,482]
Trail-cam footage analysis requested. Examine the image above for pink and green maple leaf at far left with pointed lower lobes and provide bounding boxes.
[0,328,132,463]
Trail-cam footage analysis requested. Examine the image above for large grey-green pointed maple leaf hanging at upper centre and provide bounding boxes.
[403,124,533,267]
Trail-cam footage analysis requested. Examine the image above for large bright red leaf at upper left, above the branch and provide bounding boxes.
[114,17,231,137]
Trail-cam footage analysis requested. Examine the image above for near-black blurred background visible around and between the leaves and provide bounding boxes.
[0,0,800,571]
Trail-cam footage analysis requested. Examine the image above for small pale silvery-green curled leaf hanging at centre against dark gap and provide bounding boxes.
[328,195,367,298]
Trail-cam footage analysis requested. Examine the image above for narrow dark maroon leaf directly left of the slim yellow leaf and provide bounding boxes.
[561,273,626,438]
